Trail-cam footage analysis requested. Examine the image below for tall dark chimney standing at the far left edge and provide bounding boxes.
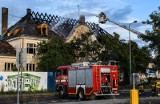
[1,7,8,36]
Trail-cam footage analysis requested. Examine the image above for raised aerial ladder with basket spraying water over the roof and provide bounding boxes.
[99,12,143,36]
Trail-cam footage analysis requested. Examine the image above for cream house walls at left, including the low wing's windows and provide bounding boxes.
[0,36,48,71]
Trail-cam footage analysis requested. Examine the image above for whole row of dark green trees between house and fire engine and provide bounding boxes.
[37,28,151,82]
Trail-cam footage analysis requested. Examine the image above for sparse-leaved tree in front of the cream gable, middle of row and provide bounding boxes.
[69,32,103,62]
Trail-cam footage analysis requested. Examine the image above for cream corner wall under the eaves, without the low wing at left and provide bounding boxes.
[7,36,48,71]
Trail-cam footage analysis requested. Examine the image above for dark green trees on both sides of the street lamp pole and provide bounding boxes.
[98,33,151,83]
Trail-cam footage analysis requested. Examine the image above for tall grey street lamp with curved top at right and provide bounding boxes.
[129,21,137,85]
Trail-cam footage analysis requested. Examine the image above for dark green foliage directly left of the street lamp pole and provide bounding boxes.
[98,33,129,66]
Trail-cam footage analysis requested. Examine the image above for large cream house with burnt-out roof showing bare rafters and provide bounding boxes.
[0,8,109,71]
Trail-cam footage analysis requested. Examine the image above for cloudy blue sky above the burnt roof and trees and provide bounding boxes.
[0,0,160,46]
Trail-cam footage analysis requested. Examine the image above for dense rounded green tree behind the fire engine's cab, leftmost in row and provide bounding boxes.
[37,36,75,71]
